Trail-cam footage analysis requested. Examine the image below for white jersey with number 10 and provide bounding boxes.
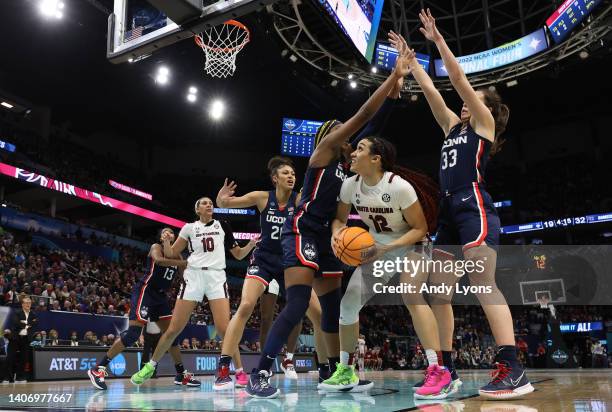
[179,219,236,270]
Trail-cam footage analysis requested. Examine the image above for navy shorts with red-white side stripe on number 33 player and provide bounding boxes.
[434,183,500,257]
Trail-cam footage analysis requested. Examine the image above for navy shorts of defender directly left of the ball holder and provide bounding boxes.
[281,216,343,278]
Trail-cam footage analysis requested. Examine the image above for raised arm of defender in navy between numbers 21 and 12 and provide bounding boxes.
[309,43,410,167]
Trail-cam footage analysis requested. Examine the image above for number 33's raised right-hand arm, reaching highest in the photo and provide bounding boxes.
[419,9,495,142]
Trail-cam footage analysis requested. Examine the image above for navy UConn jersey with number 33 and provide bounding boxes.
[440,123,492,194]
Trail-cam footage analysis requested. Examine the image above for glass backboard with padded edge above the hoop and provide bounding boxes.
[106,0,275,63]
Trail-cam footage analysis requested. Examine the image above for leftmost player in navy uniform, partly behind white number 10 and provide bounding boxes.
[87,227,200,390]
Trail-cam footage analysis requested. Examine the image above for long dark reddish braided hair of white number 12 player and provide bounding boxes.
[365,137,440,233]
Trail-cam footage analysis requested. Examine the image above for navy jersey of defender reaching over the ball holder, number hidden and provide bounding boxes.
[298,162,347,226]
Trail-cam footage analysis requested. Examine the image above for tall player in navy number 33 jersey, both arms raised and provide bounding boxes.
[391,9,534,399]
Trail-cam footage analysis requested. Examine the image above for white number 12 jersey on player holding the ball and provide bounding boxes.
[340,172,418,244]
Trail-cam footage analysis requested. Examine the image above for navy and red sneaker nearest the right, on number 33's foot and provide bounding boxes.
[478,361,534,399]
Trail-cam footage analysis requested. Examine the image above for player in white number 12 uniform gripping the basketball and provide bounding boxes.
[321,137,452,399]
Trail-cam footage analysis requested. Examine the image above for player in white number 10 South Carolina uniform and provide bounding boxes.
[131,197,255,385]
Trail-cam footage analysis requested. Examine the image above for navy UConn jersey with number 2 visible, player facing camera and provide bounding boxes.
[257,190,297,254]
